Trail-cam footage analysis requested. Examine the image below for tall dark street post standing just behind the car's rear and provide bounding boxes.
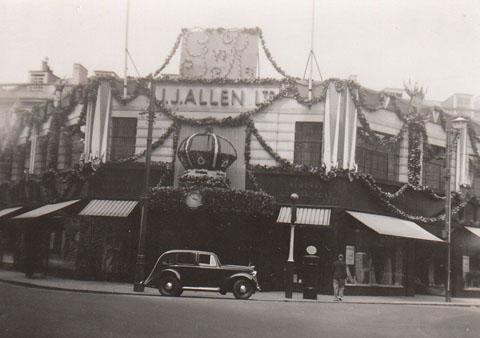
[133,80,155,292]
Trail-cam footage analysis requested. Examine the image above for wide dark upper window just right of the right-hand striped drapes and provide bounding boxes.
[355,133,400,182]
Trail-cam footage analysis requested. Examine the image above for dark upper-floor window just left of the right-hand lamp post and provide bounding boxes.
[422,146,445,191]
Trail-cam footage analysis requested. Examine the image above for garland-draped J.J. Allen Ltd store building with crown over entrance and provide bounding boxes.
[0,29,480,295]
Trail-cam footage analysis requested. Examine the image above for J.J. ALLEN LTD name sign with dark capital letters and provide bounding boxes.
[157,88,276,107]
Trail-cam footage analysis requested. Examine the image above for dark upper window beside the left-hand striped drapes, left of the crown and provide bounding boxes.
[110,117,137,161]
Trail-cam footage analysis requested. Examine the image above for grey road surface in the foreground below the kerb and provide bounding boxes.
[0,283,480,338]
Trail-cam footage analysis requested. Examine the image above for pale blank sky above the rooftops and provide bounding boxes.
[0,0,480,100]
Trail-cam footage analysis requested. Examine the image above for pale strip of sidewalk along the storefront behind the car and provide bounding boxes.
[0,270,480,307]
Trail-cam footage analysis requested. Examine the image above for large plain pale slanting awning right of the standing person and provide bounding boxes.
[347,210,443,242]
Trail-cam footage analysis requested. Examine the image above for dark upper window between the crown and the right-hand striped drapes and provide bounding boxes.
[293,122,323,167]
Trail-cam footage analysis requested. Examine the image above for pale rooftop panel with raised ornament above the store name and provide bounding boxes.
[180,28,258,79]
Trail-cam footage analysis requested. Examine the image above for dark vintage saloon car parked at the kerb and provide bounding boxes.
[143,250,260,299]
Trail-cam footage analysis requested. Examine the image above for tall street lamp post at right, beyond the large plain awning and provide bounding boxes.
[445,117,467,303]
